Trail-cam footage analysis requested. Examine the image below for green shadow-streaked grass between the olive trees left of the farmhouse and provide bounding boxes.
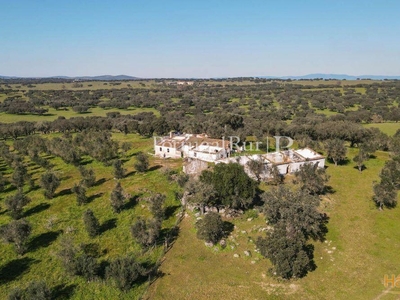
[0,134,179,299]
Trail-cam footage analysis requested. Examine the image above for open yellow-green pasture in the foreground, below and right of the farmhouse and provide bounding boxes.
[147,150,400,299]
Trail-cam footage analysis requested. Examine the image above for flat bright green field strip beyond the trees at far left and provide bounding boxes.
[0,107,160,123]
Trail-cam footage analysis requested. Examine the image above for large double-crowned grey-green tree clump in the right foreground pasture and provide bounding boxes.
[256,186,328,278]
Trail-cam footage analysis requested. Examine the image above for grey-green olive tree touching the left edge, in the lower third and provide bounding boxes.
[0,219,32,255]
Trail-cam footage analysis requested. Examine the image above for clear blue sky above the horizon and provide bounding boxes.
[0,0,400,78]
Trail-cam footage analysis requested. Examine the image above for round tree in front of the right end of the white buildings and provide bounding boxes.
[294,163,329,195]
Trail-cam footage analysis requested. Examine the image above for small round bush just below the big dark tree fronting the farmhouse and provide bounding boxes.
[196,212,224,244]
